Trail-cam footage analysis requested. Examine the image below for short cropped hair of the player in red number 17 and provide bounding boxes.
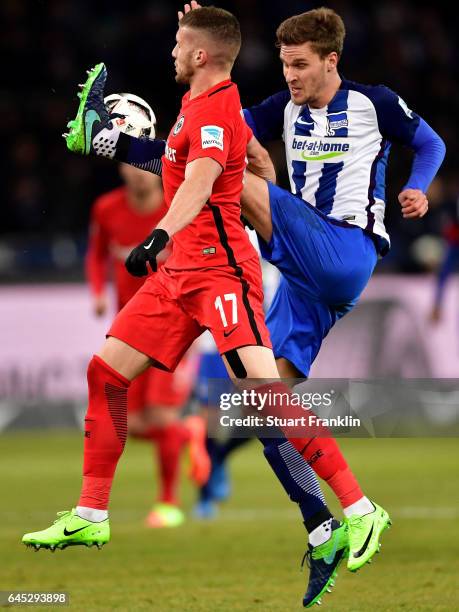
[179,6,241,65]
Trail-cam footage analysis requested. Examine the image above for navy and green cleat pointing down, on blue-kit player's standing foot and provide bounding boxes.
[302,520,349,608]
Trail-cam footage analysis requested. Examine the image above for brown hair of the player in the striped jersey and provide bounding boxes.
[276,7,346,57]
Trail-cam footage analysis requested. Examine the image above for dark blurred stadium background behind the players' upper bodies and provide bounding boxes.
[0,0,459,282]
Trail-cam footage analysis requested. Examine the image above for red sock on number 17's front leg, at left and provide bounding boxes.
[78,355,130,510]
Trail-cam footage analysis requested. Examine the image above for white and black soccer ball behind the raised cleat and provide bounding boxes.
[104,93,156,139]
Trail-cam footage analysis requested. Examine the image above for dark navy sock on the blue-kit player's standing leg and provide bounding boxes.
[259,438,332,532]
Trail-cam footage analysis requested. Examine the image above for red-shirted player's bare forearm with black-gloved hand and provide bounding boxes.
[126,157,223,276]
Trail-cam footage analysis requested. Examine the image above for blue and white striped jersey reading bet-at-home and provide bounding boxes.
[244,80,444,247]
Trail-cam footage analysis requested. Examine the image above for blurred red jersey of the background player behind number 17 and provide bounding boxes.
[86,187,167,308]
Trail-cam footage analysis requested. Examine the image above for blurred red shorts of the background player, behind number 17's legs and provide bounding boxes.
[128,356,197,412]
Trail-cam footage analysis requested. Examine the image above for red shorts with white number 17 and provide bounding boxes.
[108,256,271,372]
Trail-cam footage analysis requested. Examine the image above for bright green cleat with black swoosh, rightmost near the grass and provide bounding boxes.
[347,502,391,572]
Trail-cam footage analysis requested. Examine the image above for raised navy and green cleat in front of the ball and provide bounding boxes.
[63,63,113,155]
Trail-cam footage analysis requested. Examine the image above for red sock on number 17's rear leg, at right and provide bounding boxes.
[256,381,363,508]
